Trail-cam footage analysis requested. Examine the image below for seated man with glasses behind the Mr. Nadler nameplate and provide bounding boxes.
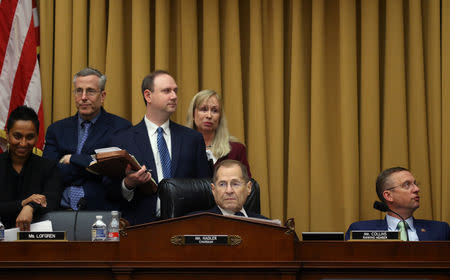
[204,159,268,219]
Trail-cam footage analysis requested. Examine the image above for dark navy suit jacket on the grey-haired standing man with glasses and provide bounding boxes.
[43,108,131,210]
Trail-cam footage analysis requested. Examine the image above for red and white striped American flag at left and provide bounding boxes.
[0,0,45,151]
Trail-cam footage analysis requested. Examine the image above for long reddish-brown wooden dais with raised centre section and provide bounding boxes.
[0,214,450,280]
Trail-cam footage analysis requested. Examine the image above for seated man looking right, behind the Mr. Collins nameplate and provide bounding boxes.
[345,167,450,241]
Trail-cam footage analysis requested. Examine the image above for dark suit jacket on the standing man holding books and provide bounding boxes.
[111,120,211,224]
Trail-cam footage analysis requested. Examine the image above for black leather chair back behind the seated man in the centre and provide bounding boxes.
[158,178,261,219]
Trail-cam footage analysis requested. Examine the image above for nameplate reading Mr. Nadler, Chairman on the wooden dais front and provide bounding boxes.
[170,235,242,246]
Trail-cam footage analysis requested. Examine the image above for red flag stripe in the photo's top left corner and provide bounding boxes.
[0,0,17,74]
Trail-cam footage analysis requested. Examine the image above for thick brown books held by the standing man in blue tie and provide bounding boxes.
[86,148,158,194]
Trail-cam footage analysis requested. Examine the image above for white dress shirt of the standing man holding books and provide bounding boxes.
[122,116,172,214]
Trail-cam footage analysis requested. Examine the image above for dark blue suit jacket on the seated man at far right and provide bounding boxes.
[345,219,450,241]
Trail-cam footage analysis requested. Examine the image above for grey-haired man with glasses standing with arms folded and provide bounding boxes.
[43,68,131,210]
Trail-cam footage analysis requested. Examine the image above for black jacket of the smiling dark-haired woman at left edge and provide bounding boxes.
[0,152,63,228]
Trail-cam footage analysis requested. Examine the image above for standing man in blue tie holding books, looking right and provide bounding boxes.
[111,70,211,224]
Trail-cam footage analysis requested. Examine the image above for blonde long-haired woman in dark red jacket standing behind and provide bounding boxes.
[186,89,251,177]
